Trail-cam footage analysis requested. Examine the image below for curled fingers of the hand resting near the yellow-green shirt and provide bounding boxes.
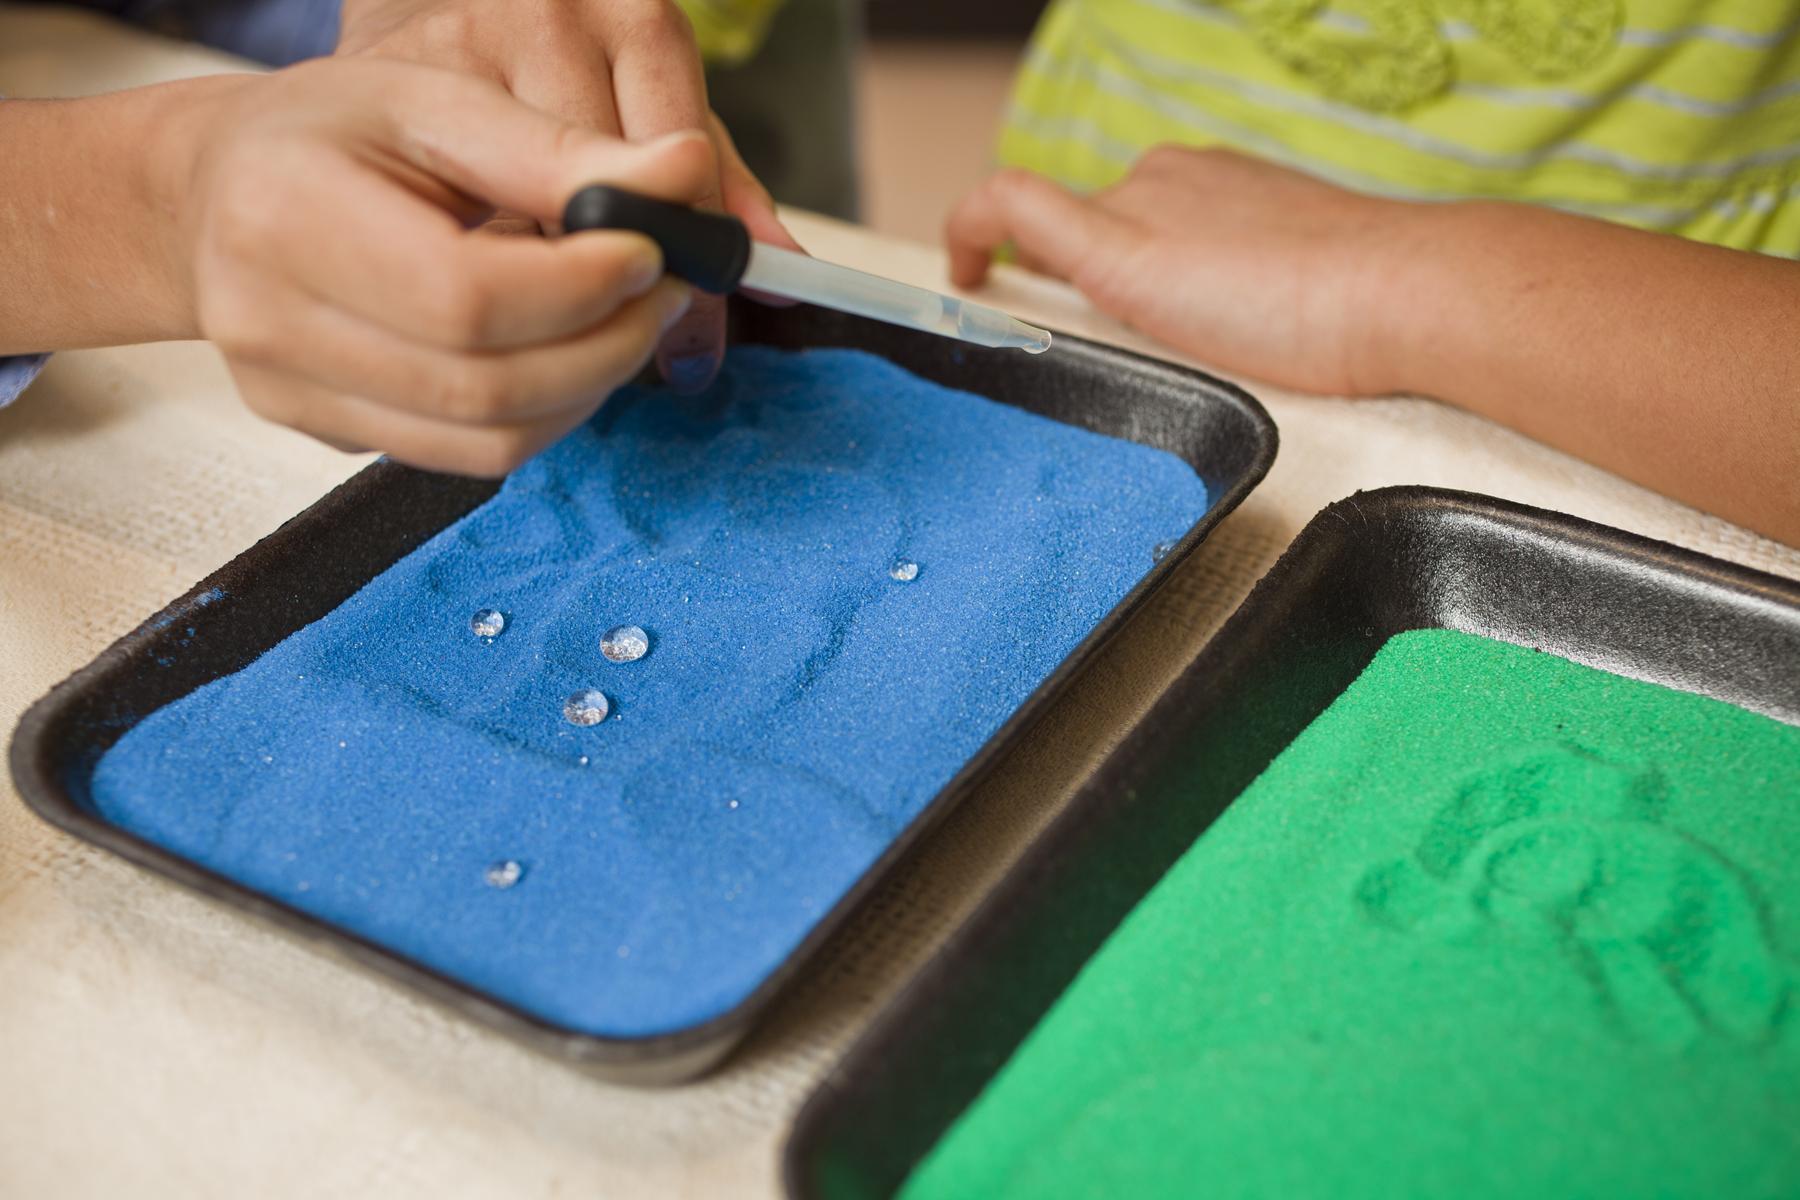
[943,171,1132,288]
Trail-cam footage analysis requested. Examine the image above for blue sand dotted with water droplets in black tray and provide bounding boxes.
[94,347,1208,1036]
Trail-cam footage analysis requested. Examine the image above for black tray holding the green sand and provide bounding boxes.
[783,488,1800,1200]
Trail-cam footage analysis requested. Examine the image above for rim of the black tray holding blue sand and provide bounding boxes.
[7,315,1280,1085]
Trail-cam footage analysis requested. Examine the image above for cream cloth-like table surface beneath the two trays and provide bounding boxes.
[0,7,1800,1198]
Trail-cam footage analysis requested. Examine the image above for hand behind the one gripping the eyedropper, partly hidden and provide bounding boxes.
[338,0,799,390]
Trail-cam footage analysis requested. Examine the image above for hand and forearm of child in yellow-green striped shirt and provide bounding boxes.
[947,146,1800,545]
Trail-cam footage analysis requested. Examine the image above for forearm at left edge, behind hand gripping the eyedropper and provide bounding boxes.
[0,76,243,354]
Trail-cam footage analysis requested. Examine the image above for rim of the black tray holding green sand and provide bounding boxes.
[779,484,1800,1200]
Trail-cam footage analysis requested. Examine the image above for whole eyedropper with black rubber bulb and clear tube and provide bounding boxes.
[563,184,1049,354]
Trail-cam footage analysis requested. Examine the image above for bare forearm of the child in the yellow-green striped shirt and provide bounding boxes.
[1372,203,1800,545]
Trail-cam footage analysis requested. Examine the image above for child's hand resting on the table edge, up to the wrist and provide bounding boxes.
[945,146,1415,394]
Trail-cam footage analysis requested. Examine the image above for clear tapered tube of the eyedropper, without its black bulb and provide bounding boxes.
[738,243,1049,354]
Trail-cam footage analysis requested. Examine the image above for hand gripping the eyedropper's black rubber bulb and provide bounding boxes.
[176,59,713,475]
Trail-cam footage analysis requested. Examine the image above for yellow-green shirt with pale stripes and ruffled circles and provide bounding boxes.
[1001,0,1800,255]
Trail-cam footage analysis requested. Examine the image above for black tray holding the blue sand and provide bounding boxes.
[11,304,1276,1083]
